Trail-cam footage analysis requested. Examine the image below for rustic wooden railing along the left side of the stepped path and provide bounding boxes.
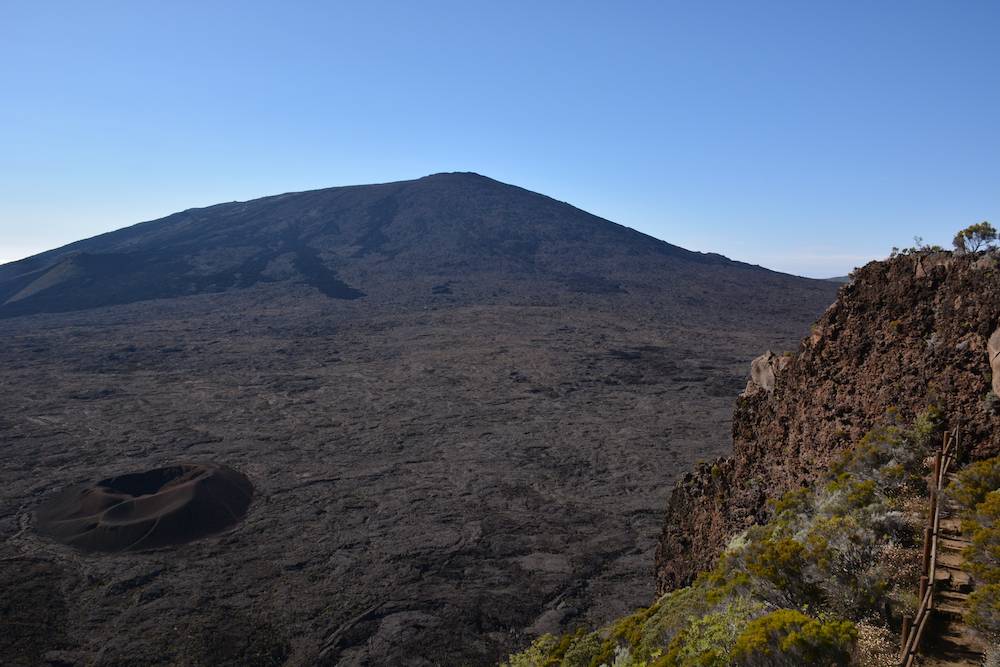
[899,426,960,667]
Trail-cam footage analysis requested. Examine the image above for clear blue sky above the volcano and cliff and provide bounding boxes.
[0,0,1000,276]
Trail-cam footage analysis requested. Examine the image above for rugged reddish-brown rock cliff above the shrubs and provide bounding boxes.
[656,252,1000,593]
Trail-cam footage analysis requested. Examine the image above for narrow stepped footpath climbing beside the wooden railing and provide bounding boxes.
[917,474,986,667]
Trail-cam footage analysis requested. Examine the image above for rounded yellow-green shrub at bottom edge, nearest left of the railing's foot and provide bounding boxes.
[733,609,857,667]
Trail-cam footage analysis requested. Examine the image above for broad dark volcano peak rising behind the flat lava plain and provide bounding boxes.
[0,173,820,322]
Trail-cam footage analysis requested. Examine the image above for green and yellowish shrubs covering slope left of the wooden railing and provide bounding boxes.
[506,408,944,667]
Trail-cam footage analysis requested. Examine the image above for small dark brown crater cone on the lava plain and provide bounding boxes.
[36,463,253,552]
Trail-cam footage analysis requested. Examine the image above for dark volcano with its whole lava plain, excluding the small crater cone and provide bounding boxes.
[0,174,836,665]
